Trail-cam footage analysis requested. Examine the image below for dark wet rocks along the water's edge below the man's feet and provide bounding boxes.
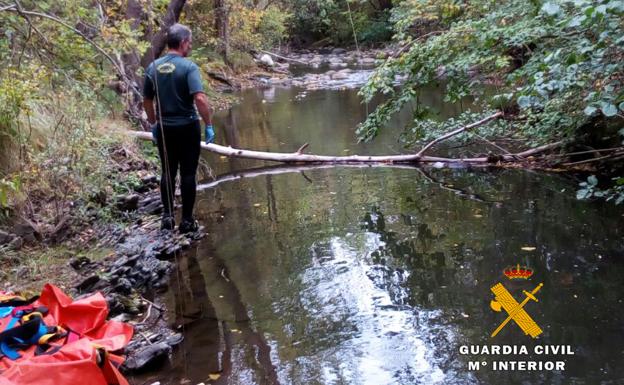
[70,192,203,373]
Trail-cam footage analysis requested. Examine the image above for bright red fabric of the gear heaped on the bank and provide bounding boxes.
[0,284,133,385]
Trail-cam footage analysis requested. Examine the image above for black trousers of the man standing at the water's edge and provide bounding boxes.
[155,120,201,220]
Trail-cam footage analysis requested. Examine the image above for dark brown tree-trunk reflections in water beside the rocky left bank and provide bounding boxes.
[162,249,279,385]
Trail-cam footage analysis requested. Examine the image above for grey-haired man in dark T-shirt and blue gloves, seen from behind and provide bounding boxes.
[143,24,214,233]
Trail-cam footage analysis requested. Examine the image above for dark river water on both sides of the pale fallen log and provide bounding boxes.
[136,82,624,385]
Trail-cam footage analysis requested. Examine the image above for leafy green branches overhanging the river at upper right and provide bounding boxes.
[358,0,624,143]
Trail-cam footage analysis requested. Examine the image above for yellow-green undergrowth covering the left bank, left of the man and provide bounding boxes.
[0,0,161,228]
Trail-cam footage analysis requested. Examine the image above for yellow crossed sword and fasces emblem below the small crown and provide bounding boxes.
[490,283,544,338]
